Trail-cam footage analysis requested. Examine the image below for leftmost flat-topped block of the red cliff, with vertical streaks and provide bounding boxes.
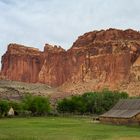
[2,44,44,83]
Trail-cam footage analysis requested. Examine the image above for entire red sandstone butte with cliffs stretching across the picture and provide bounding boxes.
[1,29,140,95]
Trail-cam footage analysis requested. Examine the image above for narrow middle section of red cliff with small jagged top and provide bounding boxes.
[38,44,66,86]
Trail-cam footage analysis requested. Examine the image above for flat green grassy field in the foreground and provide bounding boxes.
[0,117,140,140]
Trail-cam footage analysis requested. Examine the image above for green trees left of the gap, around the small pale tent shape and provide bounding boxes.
[0,94,50,117]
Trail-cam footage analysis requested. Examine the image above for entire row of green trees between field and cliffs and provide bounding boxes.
[0,89,128,117]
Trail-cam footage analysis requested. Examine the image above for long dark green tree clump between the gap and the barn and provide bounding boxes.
[57,90,128,115]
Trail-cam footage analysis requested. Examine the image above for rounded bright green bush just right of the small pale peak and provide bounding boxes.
[23,95,50,115]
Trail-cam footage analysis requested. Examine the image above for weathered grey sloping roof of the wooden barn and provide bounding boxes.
[100,99,140,118]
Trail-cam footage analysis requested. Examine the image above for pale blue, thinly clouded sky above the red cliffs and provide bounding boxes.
[0,0,140,64]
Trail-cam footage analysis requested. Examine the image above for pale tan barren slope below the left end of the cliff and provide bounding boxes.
[0,80,58,100]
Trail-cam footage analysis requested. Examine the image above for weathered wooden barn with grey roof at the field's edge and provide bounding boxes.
[99,99,140,125]
